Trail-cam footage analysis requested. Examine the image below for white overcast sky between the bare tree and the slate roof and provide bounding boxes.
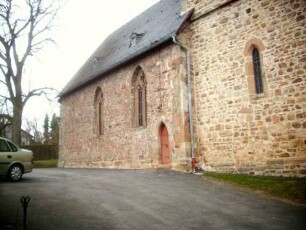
[23,0,158,128]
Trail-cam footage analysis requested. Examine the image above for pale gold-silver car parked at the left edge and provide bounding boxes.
[0,137,33,181]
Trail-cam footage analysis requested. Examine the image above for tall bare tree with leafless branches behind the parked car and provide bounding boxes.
[0,0,59,144]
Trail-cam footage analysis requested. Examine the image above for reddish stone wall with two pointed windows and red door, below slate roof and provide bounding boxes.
[59,44,190,169]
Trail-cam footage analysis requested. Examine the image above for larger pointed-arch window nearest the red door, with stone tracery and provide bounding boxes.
[131,66,147,128]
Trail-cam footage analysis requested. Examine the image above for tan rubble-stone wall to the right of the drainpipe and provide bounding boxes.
[187,0,306,177]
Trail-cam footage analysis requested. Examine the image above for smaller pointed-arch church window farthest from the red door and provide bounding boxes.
[93,87,104,136]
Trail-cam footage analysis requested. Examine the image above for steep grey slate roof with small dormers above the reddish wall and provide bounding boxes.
[59,0,190,98]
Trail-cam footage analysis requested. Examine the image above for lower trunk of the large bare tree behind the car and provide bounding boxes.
[12,99,23,146]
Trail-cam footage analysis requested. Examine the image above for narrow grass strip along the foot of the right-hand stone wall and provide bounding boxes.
[203,172,306,204]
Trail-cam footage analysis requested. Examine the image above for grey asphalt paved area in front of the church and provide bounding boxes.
[0,169,306,230]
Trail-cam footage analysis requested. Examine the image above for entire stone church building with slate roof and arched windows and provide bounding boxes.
[58,0,306,177]
